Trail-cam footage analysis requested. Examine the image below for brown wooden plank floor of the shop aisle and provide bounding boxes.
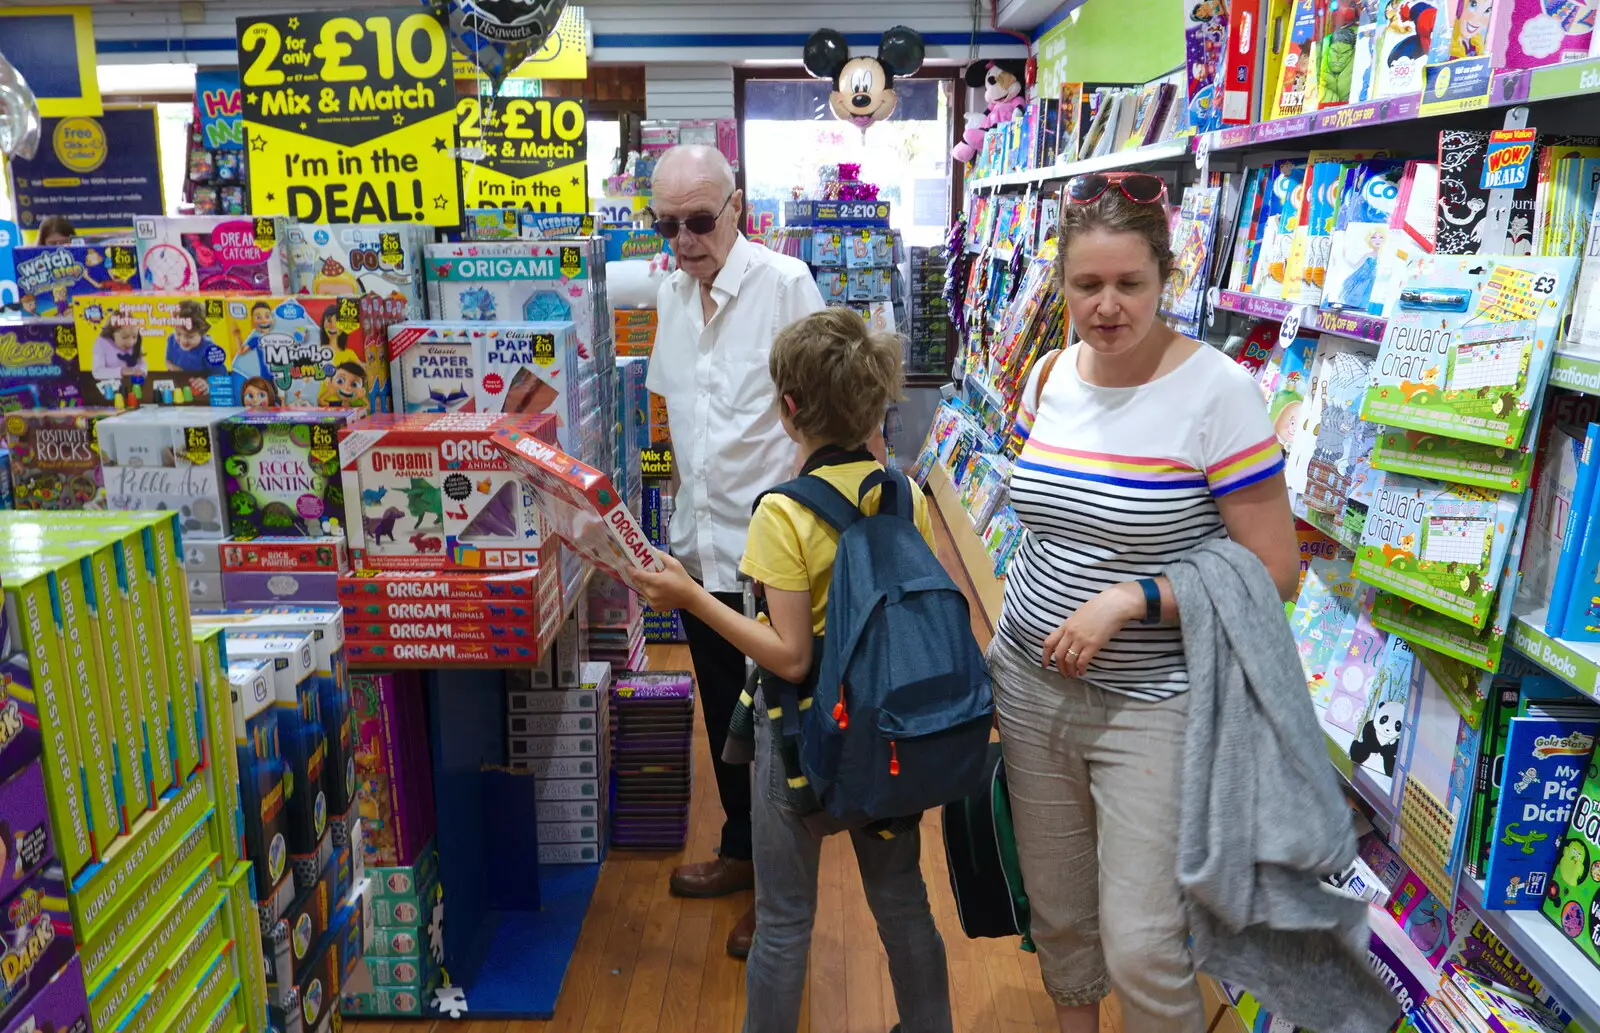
[347,517,1122,1033]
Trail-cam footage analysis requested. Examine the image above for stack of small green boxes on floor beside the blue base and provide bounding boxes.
[339,843,445,1015]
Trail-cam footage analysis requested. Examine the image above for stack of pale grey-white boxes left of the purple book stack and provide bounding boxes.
[506,664,611,865]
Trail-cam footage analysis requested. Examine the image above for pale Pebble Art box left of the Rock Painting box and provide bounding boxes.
[96,406,242,540]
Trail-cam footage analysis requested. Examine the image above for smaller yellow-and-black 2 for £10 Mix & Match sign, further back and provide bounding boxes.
[456,96,589,211]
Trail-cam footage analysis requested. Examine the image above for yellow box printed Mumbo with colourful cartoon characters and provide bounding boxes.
[234,294,389,413]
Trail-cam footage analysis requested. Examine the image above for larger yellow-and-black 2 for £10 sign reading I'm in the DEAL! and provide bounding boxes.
[238,8,461,225]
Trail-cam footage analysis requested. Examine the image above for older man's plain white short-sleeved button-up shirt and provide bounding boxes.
[645,235,822,592]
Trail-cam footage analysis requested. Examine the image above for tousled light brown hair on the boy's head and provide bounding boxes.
[768,309,902,448]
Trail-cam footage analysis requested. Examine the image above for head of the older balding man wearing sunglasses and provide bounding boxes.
[650,144,744,288]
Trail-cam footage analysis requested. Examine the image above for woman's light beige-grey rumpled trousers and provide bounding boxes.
[989,638,1205,1033]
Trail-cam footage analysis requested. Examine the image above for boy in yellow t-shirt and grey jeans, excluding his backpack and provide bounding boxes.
[635,309,950,1033]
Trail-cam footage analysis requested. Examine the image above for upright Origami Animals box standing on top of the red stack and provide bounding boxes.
[339,413,555,571]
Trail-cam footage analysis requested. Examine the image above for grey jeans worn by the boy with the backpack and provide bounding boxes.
[744,704,950,1033]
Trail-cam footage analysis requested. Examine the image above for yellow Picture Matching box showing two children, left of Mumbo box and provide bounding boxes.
[72,291,248,409]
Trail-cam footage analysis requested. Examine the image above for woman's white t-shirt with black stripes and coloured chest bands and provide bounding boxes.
[998,345,1283,700]
